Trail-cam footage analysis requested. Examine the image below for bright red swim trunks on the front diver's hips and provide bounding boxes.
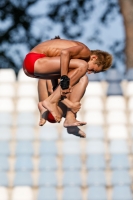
[23,52,46,78]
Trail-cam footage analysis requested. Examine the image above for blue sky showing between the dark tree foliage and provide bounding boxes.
[29,0,125,72]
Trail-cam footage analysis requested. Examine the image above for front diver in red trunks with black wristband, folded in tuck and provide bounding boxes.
[23,38,112,127]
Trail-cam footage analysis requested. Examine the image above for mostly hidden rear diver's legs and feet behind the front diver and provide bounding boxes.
[38,75,88,137]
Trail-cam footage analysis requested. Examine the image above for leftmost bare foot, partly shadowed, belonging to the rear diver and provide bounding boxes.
[38,102,48,126]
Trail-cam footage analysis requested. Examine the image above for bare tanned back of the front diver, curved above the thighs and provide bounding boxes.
[30,39,90,60]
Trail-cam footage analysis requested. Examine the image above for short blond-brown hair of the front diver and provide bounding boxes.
[91,50,113,71]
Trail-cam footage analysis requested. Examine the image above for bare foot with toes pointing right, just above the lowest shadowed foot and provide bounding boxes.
[63,118,87,128]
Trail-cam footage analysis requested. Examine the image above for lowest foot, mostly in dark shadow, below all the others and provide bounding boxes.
[67,126,86,138]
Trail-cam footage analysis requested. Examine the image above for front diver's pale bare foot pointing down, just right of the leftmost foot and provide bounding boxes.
[42,100,61,122]
